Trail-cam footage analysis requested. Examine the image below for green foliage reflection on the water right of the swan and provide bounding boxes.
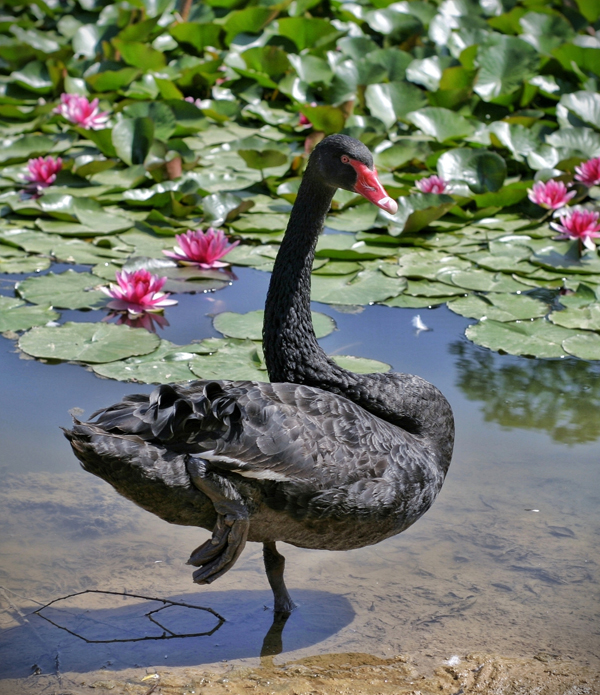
[449,341,600,444]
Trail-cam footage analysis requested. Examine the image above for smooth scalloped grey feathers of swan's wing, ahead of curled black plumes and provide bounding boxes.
[172,382,413,485]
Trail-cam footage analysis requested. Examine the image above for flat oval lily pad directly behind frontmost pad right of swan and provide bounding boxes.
[448,293,548,322]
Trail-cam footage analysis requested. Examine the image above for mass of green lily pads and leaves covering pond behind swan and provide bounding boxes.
[0,0,600,370]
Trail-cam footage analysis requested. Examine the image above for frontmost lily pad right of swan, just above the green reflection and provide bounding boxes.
[465,318,577,358]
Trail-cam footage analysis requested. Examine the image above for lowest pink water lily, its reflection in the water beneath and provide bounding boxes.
[100,269,177,315]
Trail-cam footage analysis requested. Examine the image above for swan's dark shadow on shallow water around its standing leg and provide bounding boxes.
[0,590,355,679]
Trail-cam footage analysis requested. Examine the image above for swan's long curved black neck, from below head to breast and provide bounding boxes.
[263,162,454,470]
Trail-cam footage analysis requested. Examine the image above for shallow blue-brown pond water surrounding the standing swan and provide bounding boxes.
[0,269,600,694]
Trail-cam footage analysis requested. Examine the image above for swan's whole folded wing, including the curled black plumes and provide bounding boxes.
[84,381,422,485]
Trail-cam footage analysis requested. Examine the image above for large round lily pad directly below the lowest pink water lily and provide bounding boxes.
[19,322,160,363]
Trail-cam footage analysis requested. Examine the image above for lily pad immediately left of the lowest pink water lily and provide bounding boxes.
[16,270,107,309]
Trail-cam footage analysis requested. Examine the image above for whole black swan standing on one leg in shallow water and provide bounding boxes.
[65,135,454,614]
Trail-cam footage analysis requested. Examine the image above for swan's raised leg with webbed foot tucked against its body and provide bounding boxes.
[186,457,250,584]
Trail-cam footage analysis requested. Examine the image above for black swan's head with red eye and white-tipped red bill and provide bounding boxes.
[310,134,398,215]
